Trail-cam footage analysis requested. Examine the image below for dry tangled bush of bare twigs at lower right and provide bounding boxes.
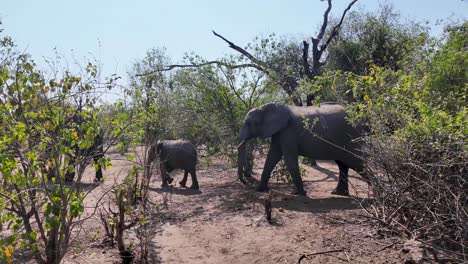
[366,138,468,262]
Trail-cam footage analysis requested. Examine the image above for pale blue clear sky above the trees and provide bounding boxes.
[0,0,468,88]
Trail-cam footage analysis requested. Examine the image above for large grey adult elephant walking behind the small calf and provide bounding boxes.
[238,103,365,195]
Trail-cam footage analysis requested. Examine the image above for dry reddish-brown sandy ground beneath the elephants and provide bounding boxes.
[56,151,420,263]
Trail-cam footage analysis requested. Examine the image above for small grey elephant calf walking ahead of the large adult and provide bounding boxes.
[148,139,199,189]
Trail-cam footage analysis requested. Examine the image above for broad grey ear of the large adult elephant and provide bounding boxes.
[261,104,291,138]
